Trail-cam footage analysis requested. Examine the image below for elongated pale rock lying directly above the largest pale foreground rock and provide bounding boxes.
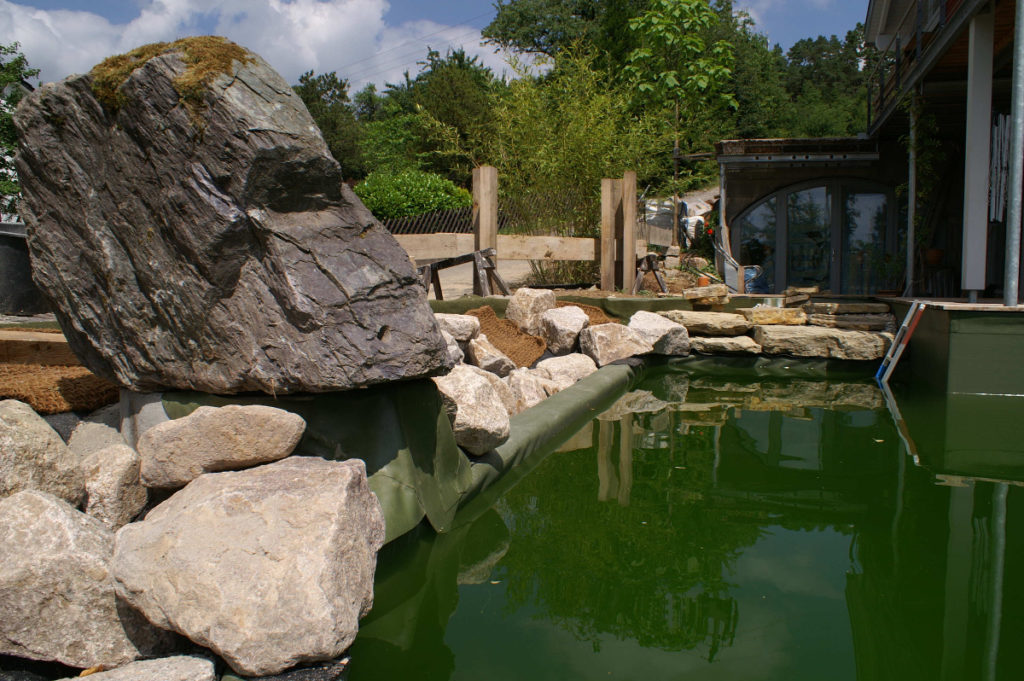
[138,405,306,487]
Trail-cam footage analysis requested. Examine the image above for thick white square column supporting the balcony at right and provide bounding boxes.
[961,11,994,300]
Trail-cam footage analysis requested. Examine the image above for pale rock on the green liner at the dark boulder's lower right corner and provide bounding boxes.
[434,365,510,456]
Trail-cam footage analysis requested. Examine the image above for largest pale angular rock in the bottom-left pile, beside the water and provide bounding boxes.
[114,457,384,676]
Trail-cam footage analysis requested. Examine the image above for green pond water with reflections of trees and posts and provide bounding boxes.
[349,373,1024,681]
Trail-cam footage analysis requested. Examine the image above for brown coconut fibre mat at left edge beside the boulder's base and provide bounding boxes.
[0,364,119,414]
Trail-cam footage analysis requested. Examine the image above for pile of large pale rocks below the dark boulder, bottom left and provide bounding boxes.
[0,395,385,681]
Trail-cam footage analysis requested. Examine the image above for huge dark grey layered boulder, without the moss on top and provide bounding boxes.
[15,39,451,394]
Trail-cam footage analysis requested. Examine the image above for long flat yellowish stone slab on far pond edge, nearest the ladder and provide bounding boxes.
[754,327,892,359]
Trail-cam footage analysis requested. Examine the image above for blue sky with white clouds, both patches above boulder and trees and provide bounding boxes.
[0,0,867,91]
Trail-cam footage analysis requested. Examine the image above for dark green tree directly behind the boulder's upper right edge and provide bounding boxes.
[294,71,366,177]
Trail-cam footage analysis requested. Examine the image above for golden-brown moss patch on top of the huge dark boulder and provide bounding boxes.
[89,36,253,118]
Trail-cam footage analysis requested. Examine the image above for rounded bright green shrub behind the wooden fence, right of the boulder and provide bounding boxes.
[355,170,473,220]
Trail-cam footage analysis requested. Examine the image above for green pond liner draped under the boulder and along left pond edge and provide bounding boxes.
[162,359,643,542]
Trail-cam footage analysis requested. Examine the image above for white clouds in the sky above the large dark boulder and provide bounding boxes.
[0,0,503,90]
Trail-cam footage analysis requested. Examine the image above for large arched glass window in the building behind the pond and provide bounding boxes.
[730,179,903,294]
